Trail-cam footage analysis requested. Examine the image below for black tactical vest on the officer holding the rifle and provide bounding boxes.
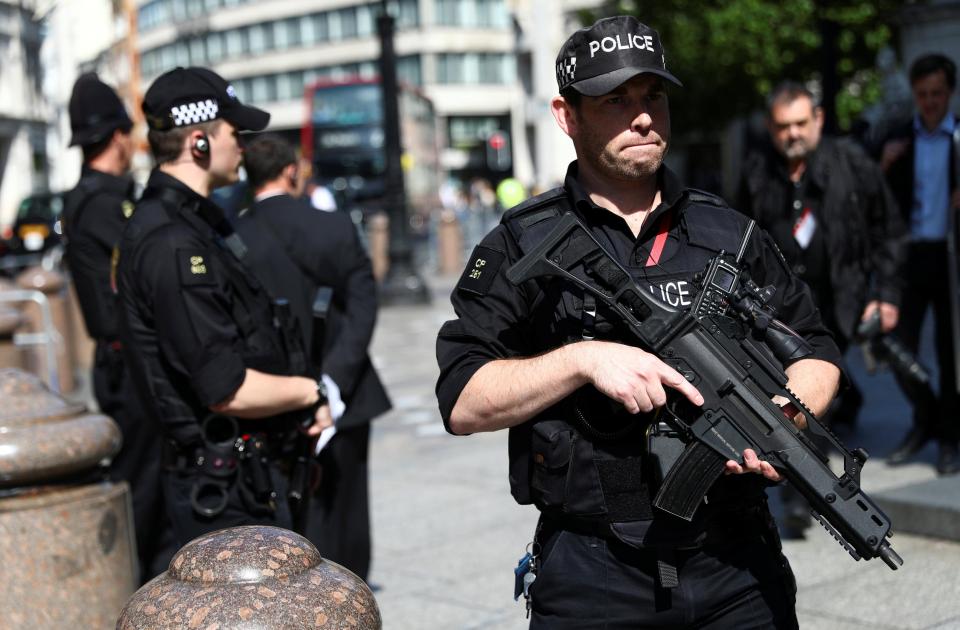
[502,188,762,546]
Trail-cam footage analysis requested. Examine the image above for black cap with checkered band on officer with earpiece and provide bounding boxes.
[143,67,270,131]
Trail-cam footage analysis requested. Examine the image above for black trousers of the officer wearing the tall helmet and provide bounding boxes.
[93,341,177,584]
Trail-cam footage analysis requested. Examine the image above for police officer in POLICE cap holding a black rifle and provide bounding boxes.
[437,16,839,628]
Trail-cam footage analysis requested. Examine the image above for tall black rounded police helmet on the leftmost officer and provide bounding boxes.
[68,72,133,147]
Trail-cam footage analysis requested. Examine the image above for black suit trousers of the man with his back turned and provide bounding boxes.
[305,423,371,581]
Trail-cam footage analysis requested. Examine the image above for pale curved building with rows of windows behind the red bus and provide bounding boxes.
[137,0,598,193]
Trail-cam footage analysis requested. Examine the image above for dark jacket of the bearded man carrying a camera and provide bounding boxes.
[737,138,907,338]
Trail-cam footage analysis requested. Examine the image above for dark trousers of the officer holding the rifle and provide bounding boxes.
[530,530,798,630]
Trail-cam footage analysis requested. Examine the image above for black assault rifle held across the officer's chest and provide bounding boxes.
[507,212,903,570]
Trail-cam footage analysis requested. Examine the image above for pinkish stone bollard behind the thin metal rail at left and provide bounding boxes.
[17,267,75,392]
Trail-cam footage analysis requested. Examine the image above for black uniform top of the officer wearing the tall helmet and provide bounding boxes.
[63,165,133,341]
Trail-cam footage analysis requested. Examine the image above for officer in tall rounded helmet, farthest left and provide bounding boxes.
[63,73,176,582]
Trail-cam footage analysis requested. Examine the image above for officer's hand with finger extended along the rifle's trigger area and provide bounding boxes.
[582,341,703,413]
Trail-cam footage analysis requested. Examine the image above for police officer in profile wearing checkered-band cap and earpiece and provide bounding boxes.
[117,68,331,545]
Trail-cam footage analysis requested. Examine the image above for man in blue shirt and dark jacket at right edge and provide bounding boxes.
[881,54,960,474]
